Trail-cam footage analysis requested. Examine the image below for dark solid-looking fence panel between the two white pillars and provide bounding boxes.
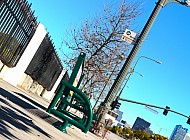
[25,34,63,90]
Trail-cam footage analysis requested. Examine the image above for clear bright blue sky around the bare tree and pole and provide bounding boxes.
[29,0,190,136]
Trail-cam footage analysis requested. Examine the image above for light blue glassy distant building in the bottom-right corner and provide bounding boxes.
[170,125,188,140]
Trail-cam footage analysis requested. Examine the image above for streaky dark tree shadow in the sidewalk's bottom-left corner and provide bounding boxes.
[0,99,52,139]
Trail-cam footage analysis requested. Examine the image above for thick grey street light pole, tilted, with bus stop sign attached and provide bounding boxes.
[98,0,189,126]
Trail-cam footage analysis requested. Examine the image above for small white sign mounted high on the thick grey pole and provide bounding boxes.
[122,29,137,44]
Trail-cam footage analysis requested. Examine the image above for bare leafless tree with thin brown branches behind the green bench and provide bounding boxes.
[61,1,142,105]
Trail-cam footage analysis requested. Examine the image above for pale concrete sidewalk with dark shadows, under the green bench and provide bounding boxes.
[0,81,102,140]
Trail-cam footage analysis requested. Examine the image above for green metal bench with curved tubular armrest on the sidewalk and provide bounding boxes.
[47,53,95,133]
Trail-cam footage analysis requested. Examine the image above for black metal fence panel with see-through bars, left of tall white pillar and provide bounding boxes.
[0,0,38,67]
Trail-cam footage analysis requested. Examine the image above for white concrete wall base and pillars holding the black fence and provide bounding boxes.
[0,24,66,100]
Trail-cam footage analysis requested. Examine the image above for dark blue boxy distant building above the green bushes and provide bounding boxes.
[132,117,151,131]
